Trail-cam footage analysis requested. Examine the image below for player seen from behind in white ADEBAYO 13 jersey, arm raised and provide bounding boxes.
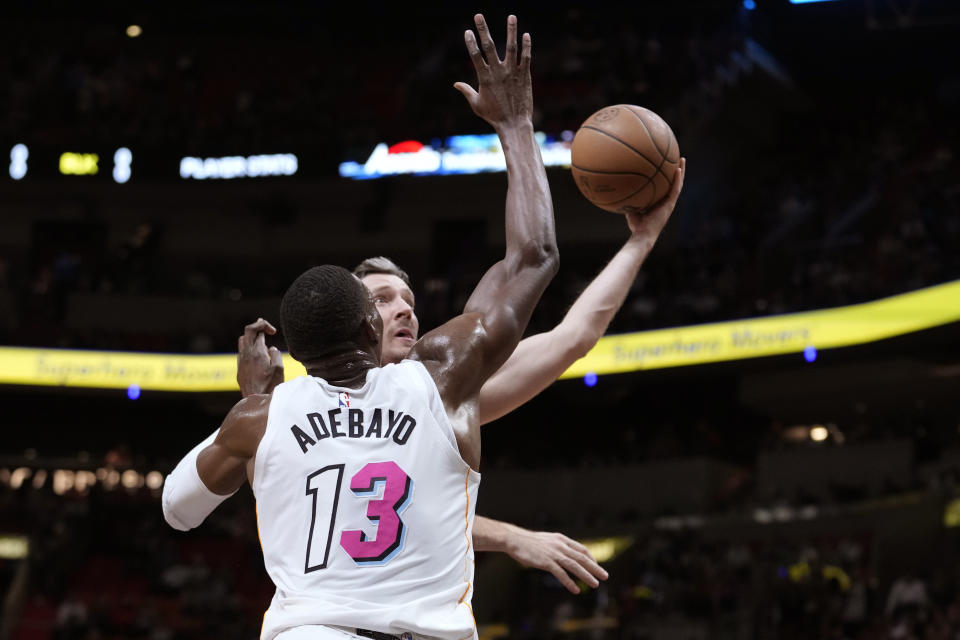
[163,15,558,640]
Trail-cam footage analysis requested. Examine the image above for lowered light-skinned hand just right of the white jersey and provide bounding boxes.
[506,529,607,593]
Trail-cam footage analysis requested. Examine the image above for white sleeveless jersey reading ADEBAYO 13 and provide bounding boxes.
[253,360,480,640]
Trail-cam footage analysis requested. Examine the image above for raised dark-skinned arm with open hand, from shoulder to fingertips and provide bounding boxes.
[410,14,559,468]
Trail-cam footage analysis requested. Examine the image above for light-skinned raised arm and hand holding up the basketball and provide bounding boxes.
[480,158,686,424]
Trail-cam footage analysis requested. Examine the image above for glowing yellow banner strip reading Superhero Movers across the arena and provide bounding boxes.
[0,280,960,399]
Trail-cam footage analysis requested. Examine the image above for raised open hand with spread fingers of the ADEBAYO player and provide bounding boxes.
[453,13,533,129]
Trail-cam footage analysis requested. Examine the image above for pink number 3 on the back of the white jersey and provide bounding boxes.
[340,462,413,565]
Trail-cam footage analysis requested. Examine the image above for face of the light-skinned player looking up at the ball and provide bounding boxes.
[362,273,420,364]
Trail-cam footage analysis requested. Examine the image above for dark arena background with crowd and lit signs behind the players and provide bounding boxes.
[0,0,960,640]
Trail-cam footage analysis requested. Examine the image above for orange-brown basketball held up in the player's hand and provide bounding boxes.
[571,104,680,214]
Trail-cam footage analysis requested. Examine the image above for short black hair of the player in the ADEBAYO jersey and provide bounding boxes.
[280,264,370,362]
